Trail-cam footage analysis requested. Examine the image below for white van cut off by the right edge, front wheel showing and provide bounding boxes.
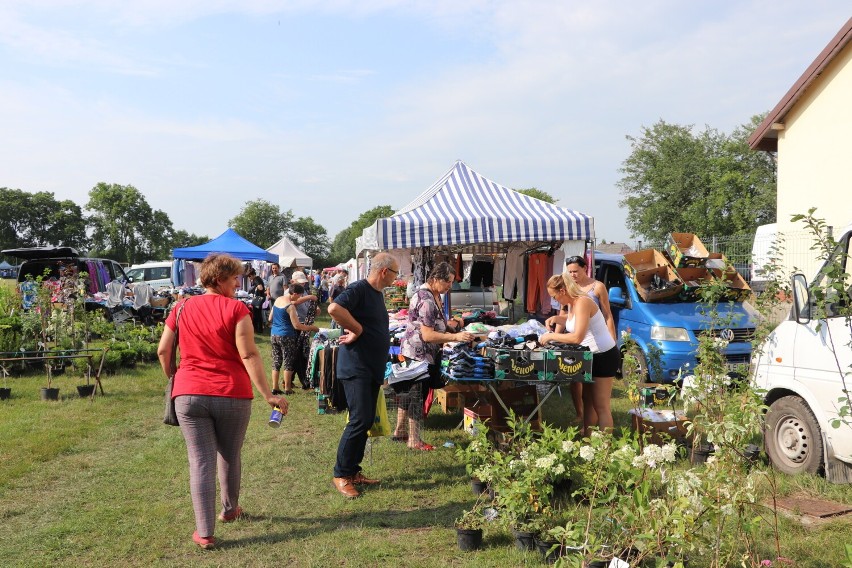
[752,225,852,483]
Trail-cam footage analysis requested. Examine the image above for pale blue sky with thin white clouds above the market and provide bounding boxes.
[0,0,852,243]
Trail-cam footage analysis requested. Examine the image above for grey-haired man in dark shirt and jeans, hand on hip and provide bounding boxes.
[328,253,399,498]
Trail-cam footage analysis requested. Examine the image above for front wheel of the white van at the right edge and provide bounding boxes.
[763,396,823,475]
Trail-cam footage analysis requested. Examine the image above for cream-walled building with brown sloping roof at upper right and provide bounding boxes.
[749,18,852,276]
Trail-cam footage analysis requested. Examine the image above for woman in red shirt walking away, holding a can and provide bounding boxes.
[157,254,287,548]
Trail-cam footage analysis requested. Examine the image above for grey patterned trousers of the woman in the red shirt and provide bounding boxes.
[175,395,251,537]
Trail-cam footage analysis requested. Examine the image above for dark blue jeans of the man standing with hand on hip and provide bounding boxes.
[334,377,381,477]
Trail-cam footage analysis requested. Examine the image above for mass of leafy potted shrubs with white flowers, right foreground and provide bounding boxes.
[456,309,780,566]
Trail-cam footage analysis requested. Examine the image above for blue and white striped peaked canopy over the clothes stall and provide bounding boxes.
[370,160,595,249]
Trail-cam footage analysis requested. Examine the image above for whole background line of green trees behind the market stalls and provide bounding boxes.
[0,116,776,266]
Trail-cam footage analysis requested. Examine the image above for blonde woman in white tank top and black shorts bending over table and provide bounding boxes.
[539,275,619,436]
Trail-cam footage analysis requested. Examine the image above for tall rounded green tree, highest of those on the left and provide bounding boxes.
[86,182,174,264]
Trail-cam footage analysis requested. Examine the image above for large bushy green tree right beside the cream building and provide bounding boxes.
[618,116,776,241]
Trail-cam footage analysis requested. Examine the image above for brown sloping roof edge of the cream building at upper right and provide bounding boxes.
[748,18,852,152]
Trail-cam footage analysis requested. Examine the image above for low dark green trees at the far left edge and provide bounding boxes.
[0,187,88,249]
